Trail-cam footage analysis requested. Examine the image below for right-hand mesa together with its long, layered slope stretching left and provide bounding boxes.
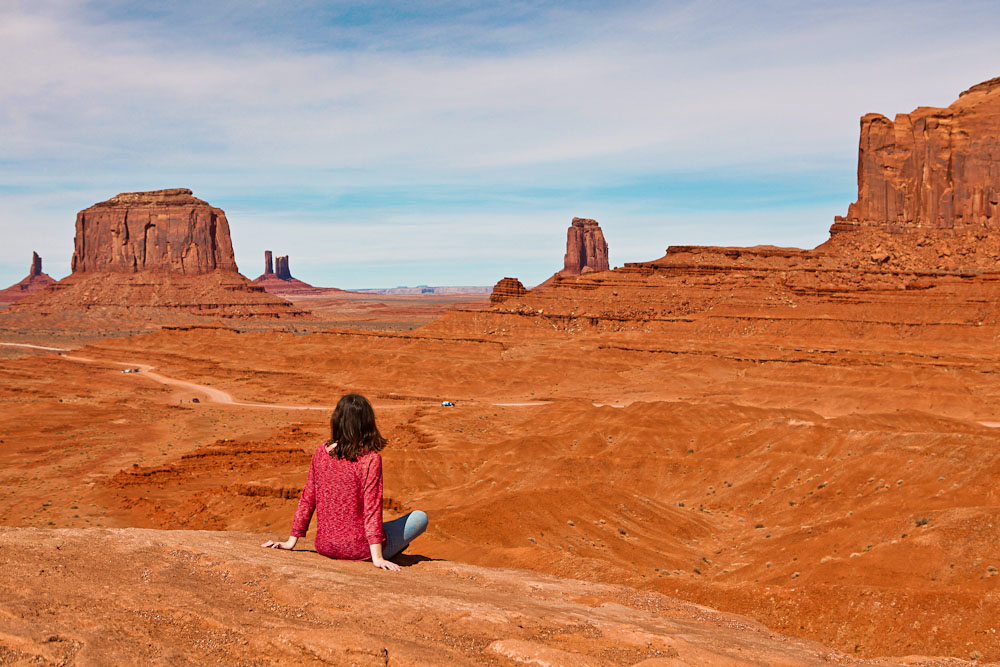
[470,78,1000,336]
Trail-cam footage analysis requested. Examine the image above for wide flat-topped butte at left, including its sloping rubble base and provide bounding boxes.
[5,188,306,326]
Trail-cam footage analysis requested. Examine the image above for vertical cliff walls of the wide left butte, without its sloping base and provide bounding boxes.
[73,188,236,275]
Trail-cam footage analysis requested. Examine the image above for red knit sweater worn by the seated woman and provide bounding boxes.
[291,445,385,560]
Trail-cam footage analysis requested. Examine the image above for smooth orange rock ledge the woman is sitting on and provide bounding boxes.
[0,528,944,665]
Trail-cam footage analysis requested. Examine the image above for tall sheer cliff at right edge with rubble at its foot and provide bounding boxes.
[821,78,1000,271]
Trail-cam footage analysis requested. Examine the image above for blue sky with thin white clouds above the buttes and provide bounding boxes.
[0,0,1000,288]
